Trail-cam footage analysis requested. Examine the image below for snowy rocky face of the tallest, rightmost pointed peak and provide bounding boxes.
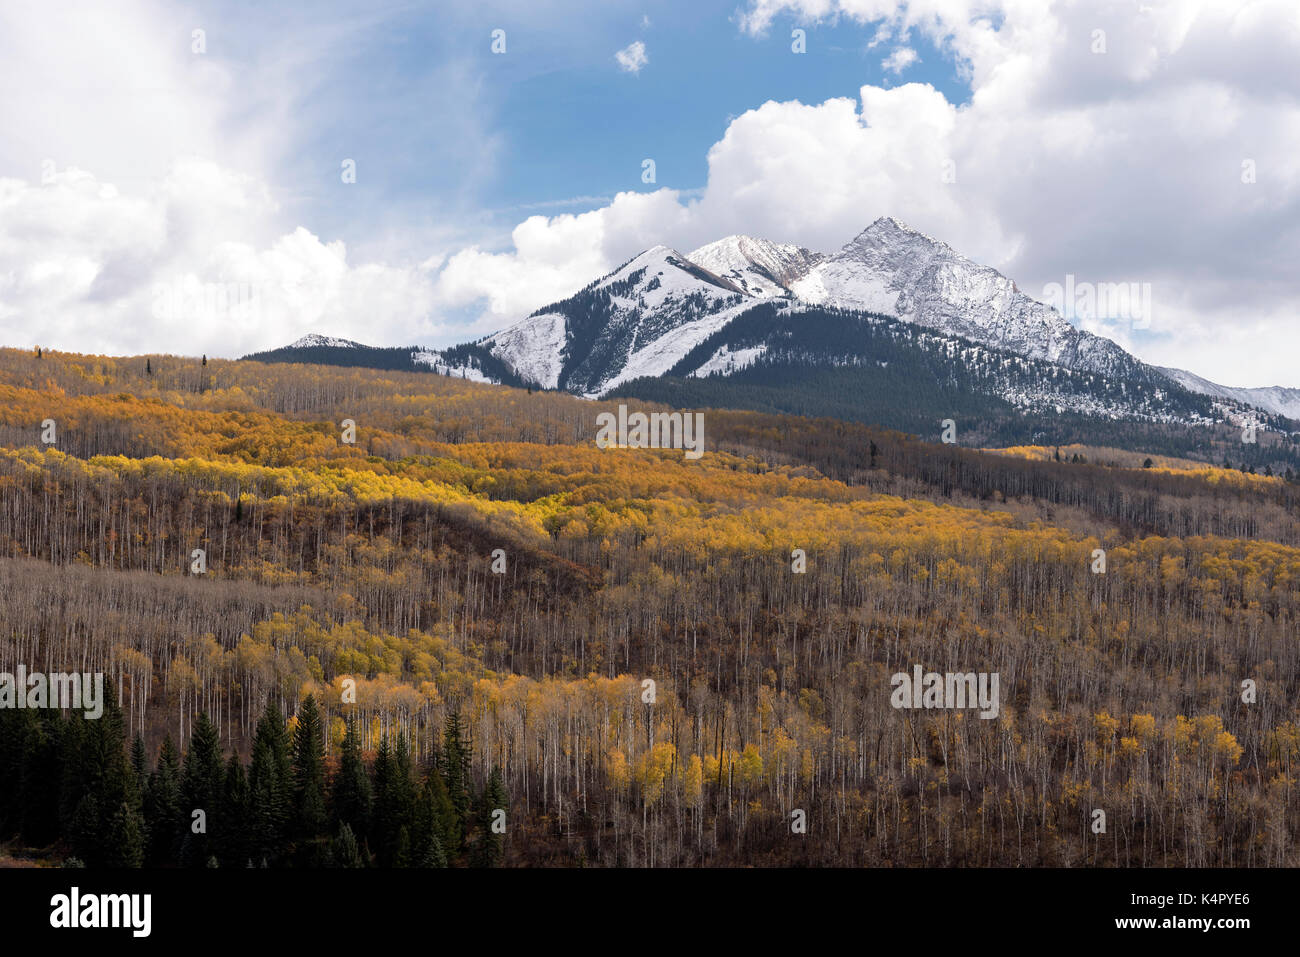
[790,216,1139,374]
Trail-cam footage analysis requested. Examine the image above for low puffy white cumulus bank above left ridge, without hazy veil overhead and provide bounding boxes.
[0,159,438,355]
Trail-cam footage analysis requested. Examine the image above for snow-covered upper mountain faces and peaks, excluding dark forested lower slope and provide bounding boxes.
[465,217,1152,395]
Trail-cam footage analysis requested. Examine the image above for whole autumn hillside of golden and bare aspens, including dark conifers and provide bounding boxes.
[0,348,1300,867]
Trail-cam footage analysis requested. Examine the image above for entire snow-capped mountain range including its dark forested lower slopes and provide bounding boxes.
[250,217,1300,443]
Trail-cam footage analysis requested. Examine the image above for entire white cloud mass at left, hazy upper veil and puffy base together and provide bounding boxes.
[0,0,473,355]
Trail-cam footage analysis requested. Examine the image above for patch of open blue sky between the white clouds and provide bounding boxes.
[266,3,970,257]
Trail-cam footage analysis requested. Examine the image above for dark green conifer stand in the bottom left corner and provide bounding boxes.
[0,684,510,867]
